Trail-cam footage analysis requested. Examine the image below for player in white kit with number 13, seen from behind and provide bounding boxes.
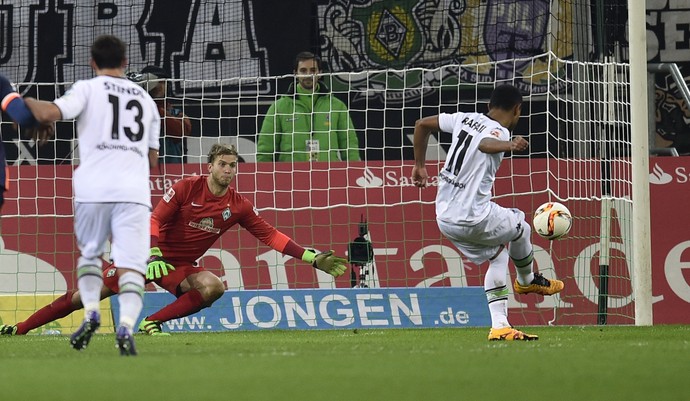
[26,35,160,355]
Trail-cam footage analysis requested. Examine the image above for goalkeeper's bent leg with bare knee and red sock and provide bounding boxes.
[139,266,225,335]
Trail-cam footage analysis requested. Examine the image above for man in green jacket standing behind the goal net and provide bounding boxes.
[256,52,360,161]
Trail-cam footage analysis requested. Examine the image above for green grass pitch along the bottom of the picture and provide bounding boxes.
[0,326,690,401]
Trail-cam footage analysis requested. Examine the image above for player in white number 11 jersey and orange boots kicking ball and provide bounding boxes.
[412,85,563,341]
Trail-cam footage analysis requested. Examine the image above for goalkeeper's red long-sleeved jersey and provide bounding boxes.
[151,176,292,265]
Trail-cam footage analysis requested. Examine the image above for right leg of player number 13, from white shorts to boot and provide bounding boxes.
[111,203,151,355]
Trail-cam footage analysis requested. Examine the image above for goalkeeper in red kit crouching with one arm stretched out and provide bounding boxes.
[0,144,346,335]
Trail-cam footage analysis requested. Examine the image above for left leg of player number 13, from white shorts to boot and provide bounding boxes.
[70,202,112,350]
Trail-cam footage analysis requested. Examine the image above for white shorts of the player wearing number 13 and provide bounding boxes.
[74,202,151,274]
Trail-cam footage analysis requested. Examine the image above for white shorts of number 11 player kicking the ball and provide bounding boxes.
[436,202,527,264]
